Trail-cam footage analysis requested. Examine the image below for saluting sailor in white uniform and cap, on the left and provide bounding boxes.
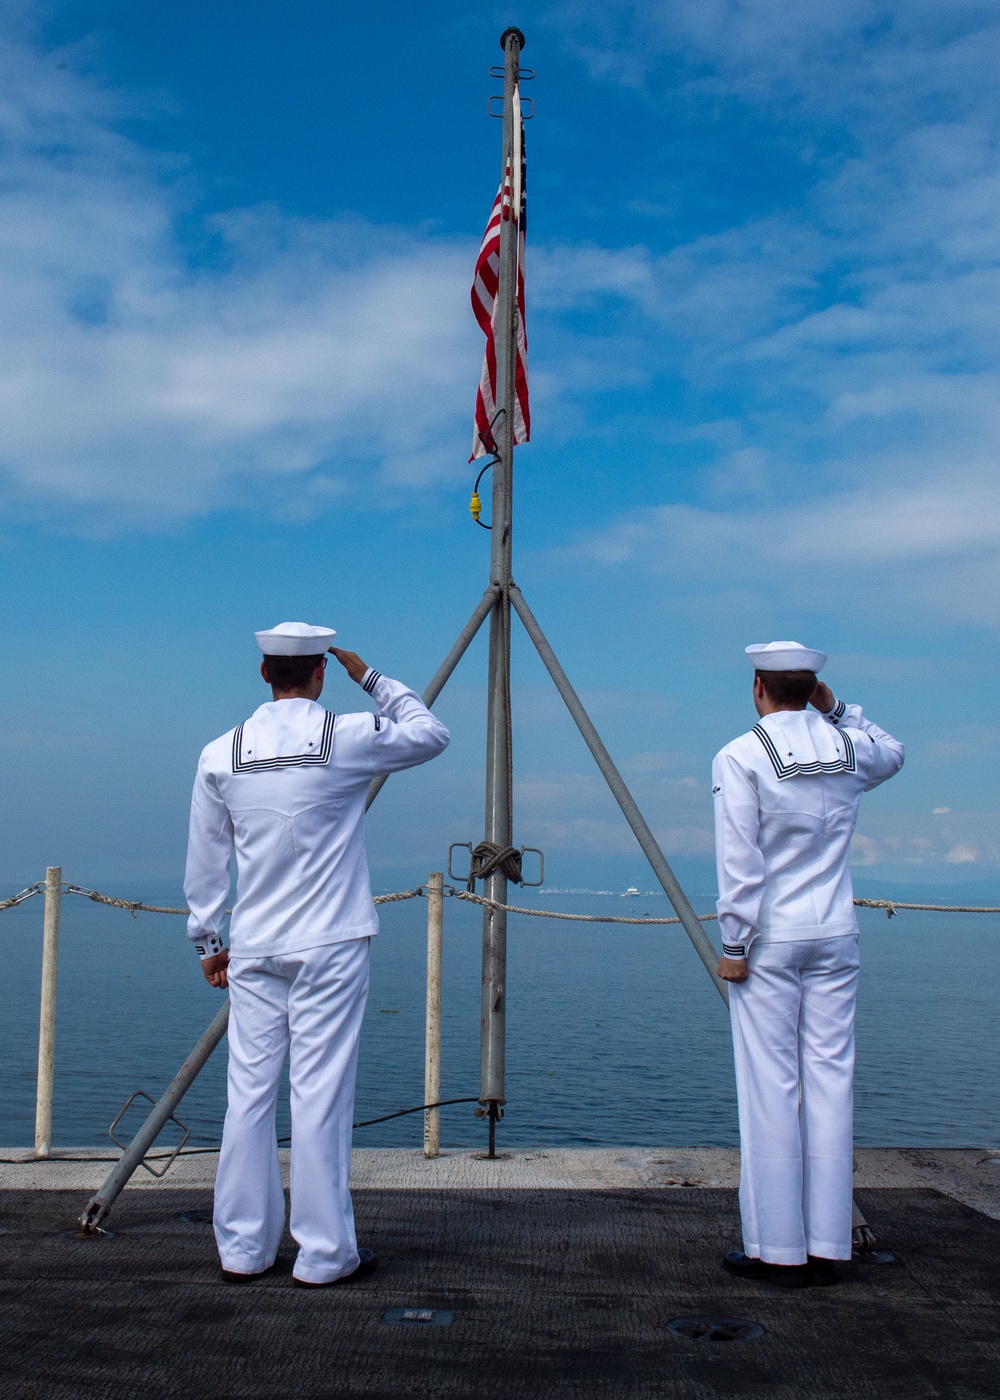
[185,623,448,1287]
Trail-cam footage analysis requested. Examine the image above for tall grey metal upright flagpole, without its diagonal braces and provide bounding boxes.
[479,28,524,1156]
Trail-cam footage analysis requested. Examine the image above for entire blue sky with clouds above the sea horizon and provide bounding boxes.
[0,0,1000,892]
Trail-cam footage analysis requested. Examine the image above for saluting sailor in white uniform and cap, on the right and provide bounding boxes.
[711,641,903,1287]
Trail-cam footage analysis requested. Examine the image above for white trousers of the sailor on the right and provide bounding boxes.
[730,934,859,1264]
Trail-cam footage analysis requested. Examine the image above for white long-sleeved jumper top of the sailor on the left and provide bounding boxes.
[183,669,450,958]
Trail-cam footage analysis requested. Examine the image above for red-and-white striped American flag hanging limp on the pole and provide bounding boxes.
[469,90,531,462]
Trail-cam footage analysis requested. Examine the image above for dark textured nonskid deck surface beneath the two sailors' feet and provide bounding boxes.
[0,1163,1000,1400]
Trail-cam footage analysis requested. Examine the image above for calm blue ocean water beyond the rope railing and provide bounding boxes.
[0,889,1000,1147]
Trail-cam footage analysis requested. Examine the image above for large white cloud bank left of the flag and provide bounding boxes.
[0,21,479,525]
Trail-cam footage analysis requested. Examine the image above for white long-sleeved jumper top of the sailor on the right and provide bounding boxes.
[711,701,903,958]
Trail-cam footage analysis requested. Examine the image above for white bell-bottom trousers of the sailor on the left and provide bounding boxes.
[214,938,370,1284]
